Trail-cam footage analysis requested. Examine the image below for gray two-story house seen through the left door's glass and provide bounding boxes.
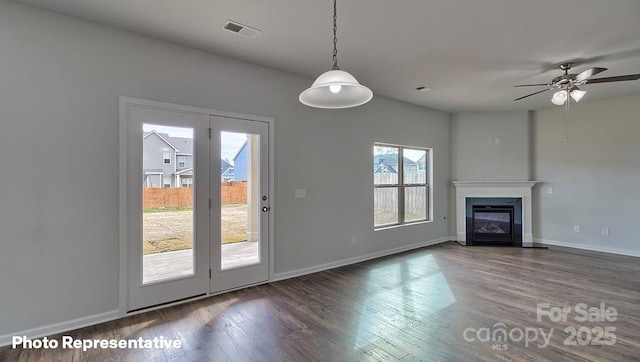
[142,131,193,187]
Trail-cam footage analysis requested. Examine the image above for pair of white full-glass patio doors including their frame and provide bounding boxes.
[121,98,270,311]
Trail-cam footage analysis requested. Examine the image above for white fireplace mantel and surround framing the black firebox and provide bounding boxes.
[453,181,537,247]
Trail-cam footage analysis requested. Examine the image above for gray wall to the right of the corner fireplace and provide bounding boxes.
[532,94,640,256]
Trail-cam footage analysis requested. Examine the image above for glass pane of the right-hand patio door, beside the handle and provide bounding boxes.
[220,132,261,270]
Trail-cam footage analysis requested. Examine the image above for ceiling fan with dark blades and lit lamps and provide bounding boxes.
[514,63,640,106]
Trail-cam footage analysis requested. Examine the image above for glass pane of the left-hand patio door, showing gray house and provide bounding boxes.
[142,123,194,284]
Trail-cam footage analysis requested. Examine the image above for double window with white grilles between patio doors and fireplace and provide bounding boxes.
[373,144,430,228]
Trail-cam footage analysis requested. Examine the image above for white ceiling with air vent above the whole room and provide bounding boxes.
[17,0,640,112]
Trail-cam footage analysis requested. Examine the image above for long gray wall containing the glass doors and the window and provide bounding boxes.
[0,0,449,335]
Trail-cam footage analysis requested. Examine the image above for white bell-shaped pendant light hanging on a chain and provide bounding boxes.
[298,0,373,109]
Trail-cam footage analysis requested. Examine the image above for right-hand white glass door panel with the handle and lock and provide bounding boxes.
[210,116,270,292]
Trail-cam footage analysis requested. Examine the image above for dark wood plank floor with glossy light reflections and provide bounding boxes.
[0,242,640,361]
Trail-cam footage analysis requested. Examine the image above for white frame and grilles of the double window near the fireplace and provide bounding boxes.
[373,142,433,230]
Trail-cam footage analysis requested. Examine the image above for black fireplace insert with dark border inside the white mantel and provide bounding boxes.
[466,197,522,246]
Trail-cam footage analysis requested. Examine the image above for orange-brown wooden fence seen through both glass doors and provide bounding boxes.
[142,181,247,209]
